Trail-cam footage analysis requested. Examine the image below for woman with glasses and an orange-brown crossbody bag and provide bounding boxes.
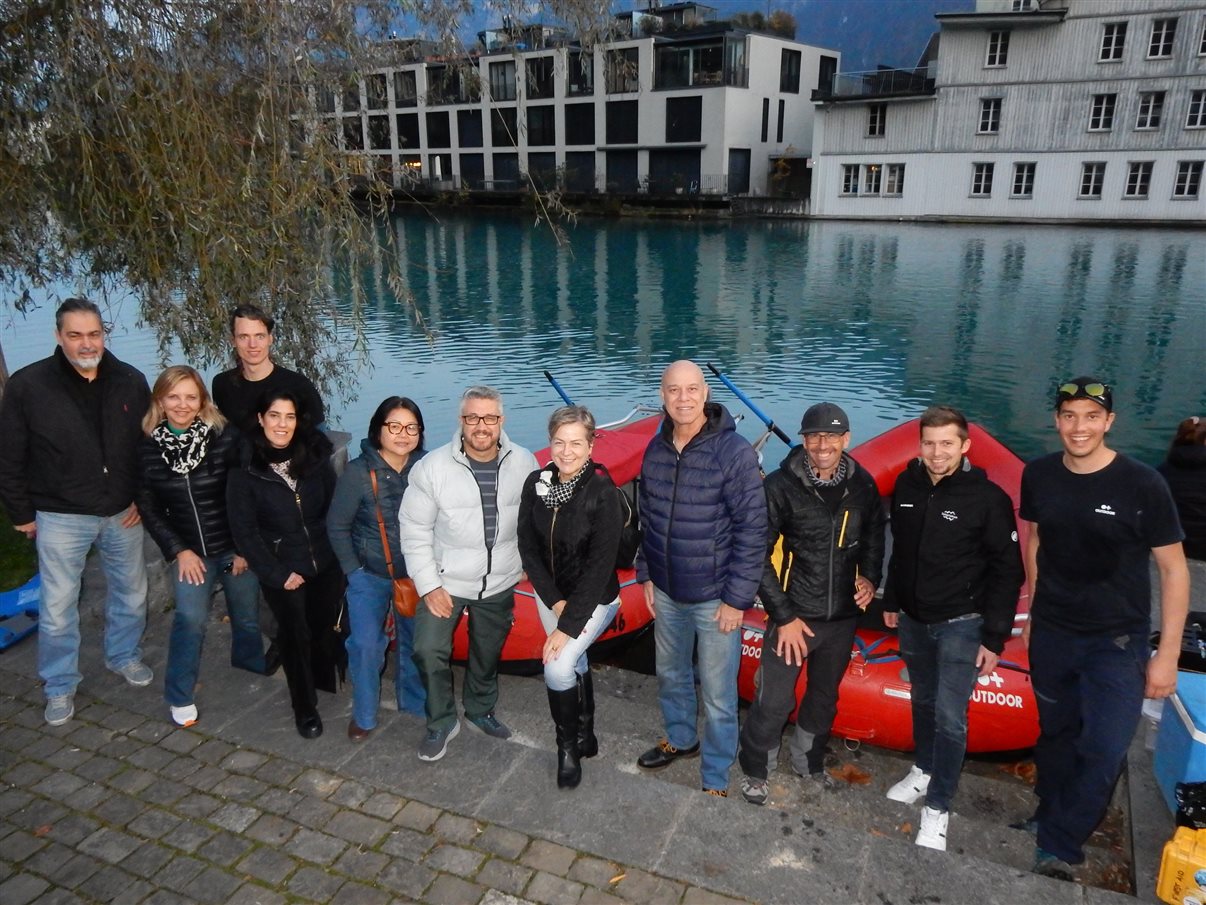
[327,396,427,742]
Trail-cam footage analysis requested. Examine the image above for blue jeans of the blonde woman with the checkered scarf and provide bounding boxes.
[163,553,264,707]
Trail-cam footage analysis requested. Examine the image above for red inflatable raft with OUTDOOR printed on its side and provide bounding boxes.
[738,420,1038,752]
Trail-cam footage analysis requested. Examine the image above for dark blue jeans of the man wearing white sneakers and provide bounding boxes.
[897,613,984,811]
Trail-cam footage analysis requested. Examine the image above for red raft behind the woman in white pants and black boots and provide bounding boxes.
[452,408,662,672]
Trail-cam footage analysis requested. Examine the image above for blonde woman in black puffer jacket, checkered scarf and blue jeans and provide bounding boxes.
[136,364,264,726]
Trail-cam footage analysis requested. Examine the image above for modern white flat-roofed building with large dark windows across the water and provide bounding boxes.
[317,4,839,197]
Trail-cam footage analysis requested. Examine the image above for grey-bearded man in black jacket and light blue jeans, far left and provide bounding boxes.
[0,298,152,726]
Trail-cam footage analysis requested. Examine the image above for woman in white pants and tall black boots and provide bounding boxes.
[519,405,624,788]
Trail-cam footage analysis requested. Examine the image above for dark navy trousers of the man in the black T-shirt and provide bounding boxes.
[1030,623,1149,864]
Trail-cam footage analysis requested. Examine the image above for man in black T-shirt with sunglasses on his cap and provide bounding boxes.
[1020,376,1189,880]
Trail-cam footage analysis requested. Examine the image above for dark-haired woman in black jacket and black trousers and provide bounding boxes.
[227,391,347,738]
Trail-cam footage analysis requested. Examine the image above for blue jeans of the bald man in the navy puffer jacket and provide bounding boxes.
[654,588,742,789]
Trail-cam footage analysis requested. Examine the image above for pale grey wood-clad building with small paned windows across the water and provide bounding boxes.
[812,0,1206,223]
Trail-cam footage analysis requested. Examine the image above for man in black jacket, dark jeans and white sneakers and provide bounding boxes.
[884,405,1024,851]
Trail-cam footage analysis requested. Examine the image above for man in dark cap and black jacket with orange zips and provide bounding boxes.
[738,402,884,805]
